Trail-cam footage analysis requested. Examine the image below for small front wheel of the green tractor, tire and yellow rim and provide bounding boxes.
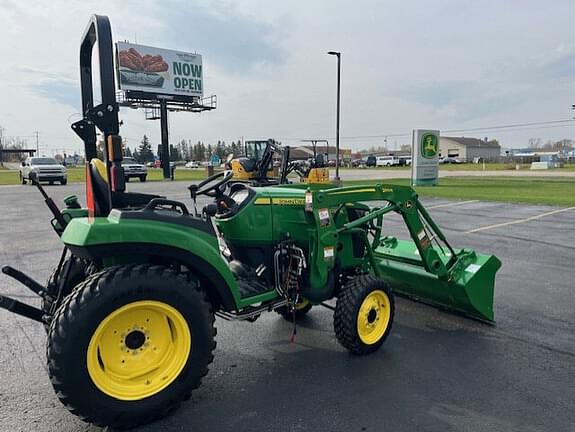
[333,275,395,355]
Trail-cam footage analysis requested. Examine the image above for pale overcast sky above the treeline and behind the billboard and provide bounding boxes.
[0,0,575,154]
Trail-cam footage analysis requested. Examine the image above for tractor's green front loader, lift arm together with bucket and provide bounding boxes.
[306,184,501,323]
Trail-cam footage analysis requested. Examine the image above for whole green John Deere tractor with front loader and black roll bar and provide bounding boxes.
[0,16,501,428]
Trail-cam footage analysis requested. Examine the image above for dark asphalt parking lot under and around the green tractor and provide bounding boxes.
[0,182,575,432]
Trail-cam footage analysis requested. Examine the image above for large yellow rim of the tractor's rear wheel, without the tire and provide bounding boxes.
[87,300,192,400]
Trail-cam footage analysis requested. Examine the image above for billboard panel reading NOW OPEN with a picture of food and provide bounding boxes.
[116,42,204,97]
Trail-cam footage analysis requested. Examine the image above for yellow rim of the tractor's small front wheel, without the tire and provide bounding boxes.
[357,290,391,345]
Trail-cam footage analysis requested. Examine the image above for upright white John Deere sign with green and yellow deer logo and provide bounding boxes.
[411,129,439,186]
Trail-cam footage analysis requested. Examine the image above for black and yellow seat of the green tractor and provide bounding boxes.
[90,159,162,216]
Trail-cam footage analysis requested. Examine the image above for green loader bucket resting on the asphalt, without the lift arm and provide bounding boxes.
[374,238,501,323]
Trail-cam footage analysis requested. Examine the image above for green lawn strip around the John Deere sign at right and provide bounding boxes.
[344,177,575,207]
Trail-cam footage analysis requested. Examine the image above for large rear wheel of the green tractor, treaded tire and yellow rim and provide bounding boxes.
[47,265,216,428]
